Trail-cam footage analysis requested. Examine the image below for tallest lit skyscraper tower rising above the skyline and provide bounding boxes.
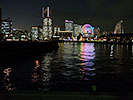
[42,7,52,39]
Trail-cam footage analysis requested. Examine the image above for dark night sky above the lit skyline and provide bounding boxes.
[0,0,133,33]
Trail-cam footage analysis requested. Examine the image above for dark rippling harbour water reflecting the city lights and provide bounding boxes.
[0,43,133,92]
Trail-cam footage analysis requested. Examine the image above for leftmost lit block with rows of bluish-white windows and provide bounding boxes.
[1,18,13,35]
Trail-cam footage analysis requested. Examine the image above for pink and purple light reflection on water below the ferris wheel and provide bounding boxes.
[80,43,96,80]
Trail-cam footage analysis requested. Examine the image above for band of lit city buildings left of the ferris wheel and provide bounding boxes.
[0,7,101,40]
